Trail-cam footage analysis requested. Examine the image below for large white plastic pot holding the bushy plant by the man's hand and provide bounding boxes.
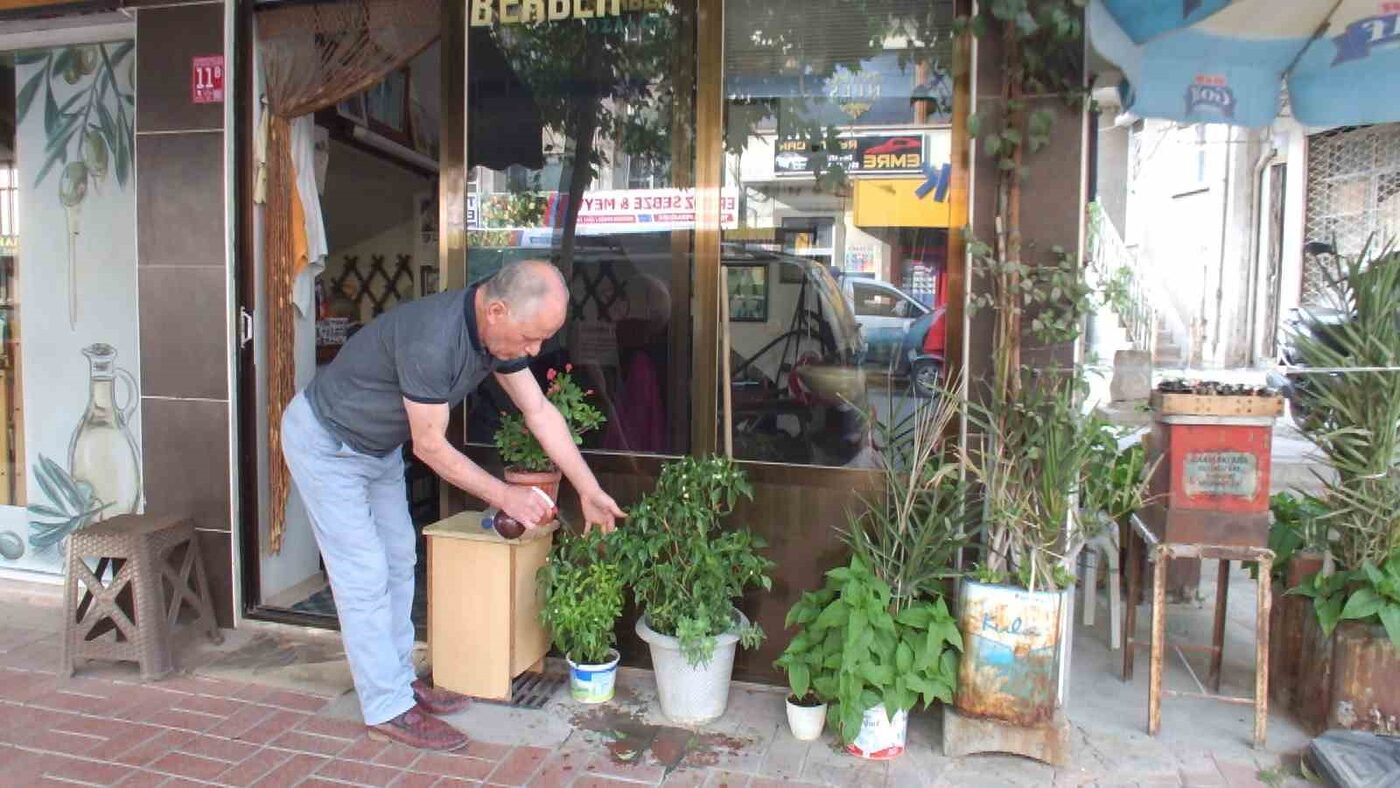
[637,612,749,725]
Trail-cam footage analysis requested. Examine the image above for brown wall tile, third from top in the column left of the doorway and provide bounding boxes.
[139,266,228,399]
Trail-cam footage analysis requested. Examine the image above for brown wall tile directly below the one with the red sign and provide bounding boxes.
[136,132,224,270]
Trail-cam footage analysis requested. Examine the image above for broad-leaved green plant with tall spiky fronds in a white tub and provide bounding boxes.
[777,386,970,760]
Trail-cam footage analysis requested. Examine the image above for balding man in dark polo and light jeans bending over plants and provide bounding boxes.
[281,260,623,750]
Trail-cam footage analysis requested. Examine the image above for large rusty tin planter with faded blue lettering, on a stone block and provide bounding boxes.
[955,581,1074,728]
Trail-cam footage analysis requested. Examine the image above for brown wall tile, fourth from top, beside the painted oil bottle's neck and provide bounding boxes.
[141,397,230,530]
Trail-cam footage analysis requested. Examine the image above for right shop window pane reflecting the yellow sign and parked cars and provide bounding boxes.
[721,0,955,467]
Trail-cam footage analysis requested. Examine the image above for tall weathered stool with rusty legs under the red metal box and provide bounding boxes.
[1123,515,1274,747]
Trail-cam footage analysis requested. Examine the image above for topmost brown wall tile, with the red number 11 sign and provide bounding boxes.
[136,3,232,132]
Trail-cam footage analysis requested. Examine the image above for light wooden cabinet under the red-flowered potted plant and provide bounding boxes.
[423,511,559,700]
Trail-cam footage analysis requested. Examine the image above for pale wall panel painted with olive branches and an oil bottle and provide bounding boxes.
[0,41,142,572]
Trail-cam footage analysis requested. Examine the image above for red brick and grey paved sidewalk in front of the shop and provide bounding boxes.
[0,576,1306,788]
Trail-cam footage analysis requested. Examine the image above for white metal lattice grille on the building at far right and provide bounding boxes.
[1302,123,1400,304]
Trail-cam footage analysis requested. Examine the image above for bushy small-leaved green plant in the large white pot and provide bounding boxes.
[617,458,773,724]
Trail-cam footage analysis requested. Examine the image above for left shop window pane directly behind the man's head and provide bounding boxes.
[468,9,696,455]
